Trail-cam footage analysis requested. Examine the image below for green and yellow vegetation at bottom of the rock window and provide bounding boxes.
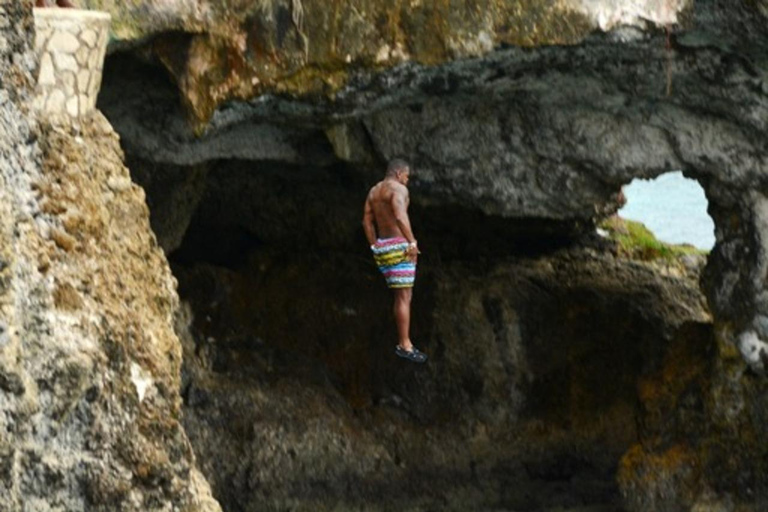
[598,215,708,261]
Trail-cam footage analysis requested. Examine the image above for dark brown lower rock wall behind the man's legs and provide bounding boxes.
[174,239,715,511]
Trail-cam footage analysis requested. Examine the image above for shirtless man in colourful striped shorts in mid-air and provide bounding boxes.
[363,159,427,363]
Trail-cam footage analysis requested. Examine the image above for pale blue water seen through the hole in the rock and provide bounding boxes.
[619,172,715,250]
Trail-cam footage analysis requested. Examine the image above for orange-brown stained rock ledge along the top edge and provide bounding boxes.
[84,0,692,122]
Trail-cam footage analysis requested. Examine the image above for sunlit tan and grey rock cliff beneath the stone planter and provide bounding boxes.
[0,1,220,512]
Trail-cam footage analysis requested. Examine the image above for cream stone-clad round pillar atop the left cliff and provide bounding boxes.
[34,8,111,118]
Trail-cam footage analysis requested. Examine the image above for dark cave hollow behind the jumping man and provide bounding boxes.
[97,48,712,511]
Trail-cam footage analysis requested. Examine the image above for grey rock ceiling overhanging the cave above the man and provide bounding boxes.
[96,2,765,223]
